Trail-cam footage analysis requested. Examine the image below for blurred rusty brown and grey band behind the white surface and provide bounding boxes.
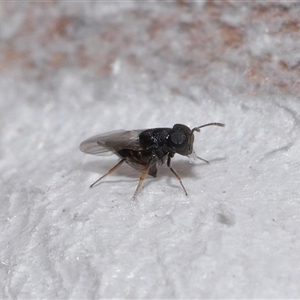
[1,1,299,94]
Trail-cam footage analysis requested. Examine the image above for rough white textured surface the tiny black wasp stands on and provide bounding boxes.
[0,5,300,299]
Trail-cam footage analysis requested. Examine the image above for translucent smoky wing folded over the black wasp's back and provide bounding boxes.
[80,130,144,155]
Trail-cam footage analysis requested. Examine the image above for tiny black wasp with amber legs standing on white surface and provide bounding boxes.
[80,123,225,198]
